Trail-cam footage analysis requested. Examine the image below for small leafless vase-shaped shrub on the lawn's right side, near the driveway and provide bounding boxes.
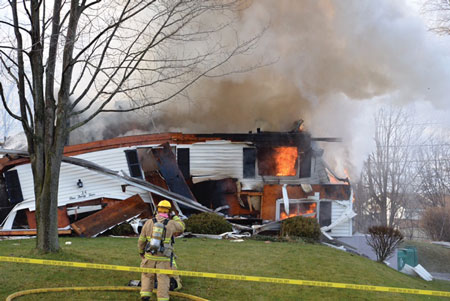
[366,226,403,262]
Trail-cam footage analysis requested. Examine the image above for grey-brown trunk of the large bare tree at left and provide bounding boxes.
[29,0,73,253]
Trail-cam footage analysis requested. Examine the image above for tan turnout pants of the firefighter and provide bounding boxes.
[141,258,170,301]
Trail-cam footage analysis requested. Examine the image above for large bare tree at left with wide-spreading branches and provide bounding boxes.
[0,0,258,252]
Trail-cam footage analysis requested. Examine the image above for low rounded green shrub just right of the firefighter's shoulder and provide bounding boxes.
[185,212,233,234]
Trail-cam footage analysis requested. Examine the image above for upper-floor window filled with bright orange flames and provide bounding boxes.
[257,146,298,177]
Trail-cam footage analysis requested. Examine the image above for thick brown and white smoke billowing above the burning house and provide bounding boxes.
[72,0,449,176]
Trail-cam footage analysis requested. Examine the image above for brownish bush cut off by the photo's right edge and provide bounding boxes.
[420,207,450,241]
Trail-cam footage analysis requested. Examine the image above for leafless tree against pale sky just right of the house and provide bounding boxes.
[359,107,419,226]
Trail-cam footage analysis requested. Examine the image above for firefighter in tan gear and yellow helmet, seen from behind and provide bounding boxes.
[138,200,185,301]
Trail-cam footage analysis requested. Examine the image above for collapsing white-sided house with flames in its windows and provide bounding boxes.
[0,124,355,237]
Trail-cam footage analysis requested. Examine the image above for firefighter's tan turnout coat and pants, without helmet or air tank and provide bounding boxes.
[138,214,185,301]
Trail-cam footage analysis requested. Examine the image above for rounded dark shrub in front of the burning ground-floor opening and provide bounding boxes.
[281,216,321,241]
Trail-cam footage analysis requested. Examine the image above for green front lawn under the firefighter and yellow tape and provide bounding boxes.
[0,237,450,300]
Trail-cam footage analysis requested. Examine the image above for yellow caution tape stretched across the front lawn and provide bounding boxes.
[0,256,450,297]
